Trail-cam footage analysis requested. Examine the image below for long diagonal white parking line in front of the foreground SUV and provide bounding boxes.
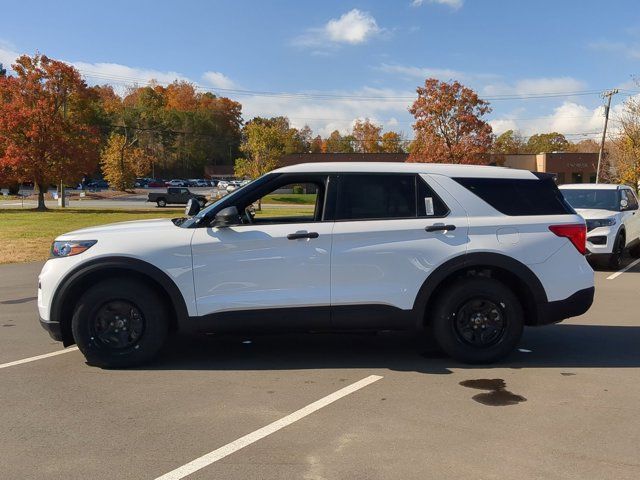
[156,375,382,480]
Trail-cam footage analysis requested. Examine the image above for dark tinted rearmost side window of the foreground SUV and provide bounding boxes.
[454,177,575,216]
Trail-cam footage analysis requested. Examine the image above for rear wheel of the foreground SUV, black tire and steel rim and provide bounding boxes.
[430,277,524,364]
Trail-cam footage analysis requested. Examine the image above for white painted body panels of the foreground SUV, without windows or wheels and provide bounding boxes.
[38,163,594,320]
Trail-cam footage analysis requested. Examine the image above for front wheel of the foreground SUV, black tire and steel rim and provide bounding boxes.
[71,278,169,368]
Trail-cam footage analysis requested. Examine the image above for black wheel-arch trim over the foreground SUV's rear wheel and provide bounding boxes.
[413,252,548,322]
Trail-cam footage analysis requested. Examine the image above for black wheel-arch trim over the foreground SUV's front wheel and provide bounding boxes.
[50,256,189,346]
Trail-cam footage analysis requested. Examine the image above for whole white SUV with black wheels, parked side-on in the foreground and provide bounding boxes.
[38,163,594,367]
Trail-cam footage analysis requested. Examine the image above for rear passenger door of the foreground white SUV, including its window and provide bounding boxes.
[331,173,468,328]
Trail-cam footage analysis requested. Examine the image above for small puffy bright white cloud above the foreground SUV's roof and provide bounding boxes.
[292,8,383,47]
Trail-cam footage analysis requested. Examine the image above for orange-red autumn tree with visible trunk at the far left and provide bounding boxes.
[0,54,99,210]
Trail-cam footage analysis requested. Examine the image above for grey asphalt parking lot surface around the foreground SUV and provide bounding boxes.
[0,263,640,480]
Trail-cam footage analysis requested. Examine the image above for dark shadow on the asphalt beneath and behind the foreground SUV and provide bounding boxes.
[142,324,640,374]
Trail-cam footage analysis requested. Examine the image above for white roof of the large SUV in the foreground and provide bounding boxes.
[274,162,538,180]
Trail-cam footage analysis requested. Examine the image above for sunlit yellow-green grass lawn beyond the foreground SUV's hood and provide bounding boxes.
[0,208,183,264]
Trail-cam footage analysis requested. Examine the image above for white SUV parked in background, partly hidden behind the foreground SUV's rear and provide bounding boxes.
[560,183,640,269]
